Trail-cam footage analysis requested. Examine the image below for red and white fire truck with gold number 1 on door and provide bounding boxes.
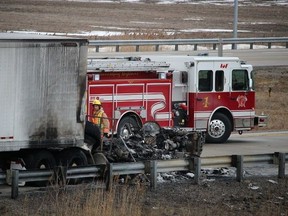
[86,55,267,143]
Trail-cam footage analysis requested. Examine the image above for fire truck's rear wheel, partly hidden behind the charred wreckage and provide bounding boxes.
[117,116,140,139]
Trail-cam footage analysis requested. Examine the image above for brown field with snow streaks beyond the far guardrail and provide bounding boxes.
[0,0,288,38]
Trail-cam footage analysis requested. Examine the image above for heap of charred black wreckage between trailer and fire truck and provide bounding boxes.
[85,122,205,163]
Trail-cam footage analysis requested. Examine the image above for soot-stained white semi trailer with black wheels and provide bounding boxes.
[0,33,88,170]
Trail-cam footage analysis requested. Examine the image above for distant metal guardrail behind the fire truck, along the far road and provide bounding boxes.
[89,37,288,53]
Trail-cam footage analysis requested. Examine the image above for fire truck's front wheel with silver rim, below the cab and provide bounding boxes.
[206,113,232,143]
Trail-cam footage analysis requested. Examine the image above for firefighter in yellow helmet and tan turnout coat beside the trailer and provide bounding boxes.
[92,99,110,138]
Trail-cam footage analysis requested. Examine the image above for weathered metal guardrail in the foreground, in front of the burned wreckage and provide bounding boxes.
[0,152,288,199]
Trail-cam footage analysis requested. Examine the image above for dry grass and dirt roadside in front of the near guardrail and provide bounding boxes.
[7,179,288,216]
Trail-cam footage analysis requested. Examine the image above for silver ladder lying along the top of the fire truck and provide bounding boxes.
[87,57,170,72]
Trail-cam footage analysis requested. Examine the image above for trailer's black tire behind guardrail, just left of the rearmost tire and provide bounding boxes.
[23,150,56,187]
